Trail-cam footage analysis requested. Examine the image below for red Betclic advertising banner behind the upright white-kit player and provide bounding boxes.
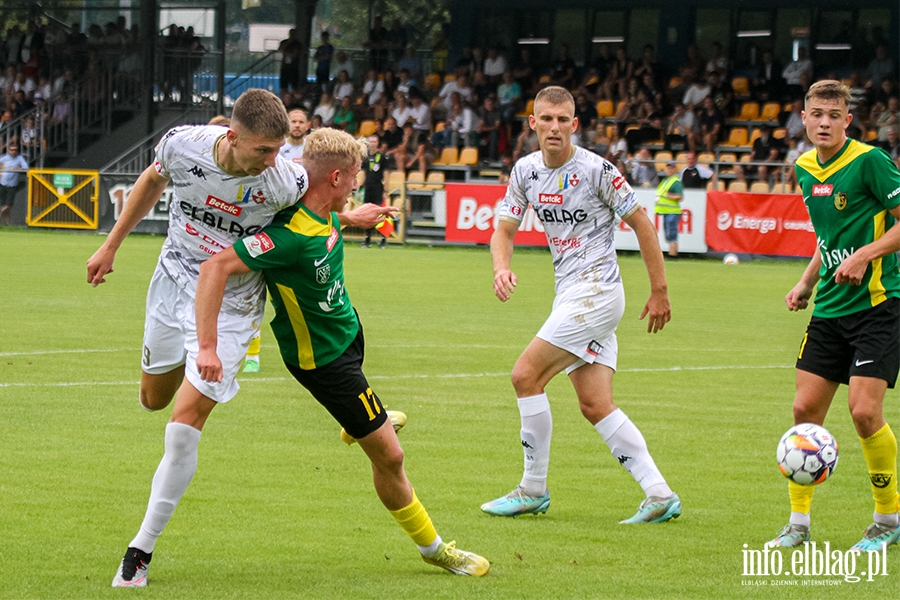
[445,183,547,246]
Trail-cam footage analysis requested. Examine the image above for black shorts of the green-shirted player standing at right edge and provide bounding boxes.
[797,298,900,388]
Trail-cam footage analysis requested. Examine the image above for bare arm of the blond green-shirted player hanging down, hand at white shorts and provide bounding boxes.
[194,247,250,382]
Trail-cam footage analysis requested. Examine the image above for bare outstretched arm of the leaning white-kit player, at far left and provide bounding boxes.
[87,165,169,287]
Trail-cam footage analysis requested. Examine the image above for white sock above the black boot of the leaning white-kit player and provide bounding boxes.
[129,423,200,552]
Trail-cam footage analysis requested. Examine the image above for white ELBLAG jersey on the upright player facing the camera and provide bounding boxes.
[500,147,640,294]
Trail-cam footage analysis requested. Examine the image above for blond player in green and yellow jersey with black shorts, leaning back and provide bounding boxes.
[197,128,490,576]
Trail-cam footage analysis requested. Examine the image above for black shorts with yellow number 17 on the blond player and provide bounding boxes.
[285,317,387,439]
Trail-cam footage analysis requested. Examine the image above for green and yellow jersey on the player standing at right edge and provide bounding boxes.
[795,139,900,317]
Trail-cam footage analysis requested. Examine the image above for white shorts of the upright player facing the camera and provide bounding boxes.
[537,282,625,374]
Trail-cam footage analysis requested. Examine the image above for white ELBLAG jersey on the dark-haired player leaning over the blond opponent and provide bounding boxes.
[154,125,309,314]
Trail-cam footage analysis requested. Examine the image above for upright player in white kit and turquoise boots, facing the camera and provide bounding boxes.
[481,86,681,523]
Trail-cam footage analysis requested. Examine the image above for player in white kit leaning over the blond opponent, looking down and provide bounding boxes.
[87,89,394,587]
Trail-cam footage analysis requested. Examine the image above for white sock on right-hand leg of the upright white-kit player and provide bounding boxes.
[594,408,672,498]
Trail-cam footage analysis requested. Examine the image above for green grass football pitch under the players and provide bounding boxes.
[0,229,900,599]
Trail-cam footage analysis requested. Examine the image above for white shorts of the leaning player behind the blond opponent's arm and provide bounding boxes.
[141,267,264,403]
